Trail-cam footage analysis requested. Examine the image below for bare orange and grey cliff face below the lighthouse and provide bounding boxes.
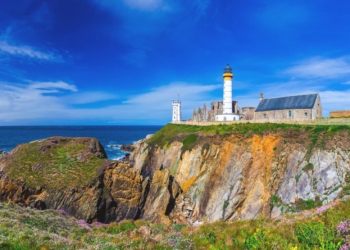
[131,127,350,222]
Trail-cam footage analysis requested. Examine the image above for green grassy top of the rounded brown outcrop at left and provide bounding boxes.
[6,139,105,188]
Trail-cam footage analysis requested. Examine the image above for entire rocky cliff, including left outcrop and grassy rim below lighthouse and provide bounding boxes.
[0,124,350,224]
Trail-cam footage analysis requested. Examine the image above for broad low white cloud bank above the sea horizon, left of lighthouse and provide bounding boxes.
[0,81,221,125]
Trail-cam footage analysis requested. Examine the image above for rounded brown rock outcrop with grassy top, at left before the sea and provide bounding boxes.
[0,137,143,223]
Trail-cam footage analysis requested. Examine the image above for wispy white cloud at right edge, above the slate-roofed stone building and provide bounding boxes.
[283,57,350,79]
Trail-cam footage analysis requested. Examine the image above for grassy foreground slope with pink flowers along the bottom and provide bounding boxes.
[0,200,350,250]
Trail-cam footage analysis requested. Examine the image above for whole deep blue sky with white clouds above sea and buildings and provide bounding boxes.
[0,0,350,125]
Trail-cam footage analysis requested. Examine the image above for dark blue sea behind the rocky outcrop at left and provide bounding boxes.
[0,126,162,160]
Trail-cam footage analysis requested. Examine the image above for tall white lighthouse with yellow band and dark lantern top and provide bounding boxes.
[215,64,239,121]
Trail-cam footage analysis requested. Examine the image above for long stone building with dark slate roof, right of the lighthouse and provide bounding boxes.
[254,94,322,122]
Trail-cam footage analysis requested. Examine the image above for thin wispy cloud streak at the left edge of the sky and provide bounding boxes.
[0,41,63,62]
